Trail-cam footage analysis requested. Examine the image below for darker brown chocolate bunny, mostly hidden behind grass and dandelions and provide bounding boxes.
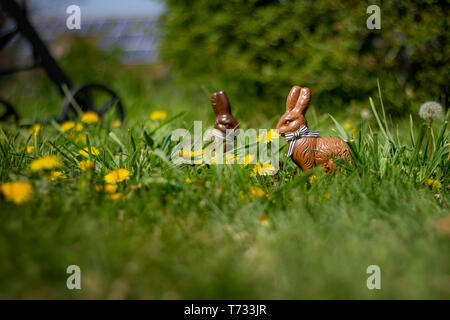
[211,91,239,151]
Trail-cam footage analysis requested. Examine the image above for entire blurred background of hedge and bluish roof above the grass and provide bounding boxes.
[0,0,450,125]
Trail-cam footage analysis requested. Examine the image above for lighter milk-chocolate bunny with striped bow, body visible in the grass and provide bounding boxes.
[277,86,350,172]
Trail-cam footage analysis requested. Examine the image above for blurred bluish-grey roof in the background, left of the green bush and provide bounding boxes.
[0,0,164,63]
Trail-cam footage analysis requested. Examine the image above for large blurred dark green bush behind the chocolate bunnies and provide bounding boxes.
[160,0,450,115]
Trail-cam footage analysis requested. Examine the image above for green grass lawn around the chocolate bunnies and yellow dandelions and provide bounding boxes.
[0,69,450,299]
